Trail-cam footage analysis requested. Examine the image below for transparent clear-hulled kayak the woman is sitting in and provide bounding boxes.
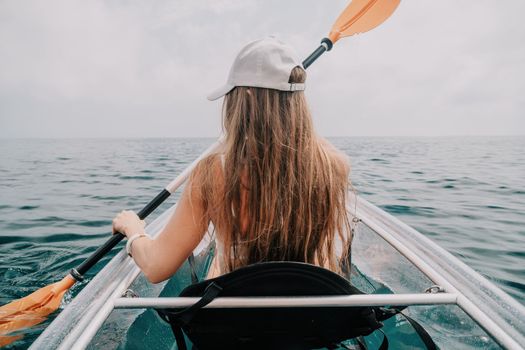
[30,162,525,349]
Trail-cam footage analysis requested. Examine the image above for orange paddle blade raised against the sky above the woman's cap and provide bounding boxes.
[328,0,401,43]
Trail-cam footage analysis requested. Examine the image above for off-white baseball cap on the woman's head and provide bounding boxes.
[208,37,305,101]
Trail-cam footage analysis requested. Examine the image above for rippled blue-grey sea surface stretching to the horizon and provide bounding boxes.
[0,137,525,347]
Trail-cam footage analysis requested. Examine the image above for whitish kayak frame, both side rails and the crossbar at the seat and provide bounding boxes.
[30,141,525,349]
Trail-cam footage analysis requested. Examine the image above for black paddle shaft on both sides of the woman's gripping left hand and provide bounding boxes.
[70,189,171,281]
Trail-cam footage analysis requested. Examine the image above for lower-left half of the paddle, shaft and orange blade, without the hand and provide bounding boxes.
[0,141,220,346]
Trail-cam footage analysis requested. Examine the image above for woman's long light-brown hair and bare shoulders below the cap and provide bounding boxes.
[192,67,352,272]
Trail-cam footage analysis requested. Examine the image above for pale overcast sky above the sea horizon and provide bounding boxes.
[0,0,525,138]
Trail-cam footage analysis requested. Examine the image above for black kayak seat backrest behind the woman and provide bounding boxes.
[157,262,432,350]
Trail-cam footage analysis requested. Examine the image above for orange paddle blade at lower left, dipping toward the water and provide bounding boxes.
[0,275,76,346]
